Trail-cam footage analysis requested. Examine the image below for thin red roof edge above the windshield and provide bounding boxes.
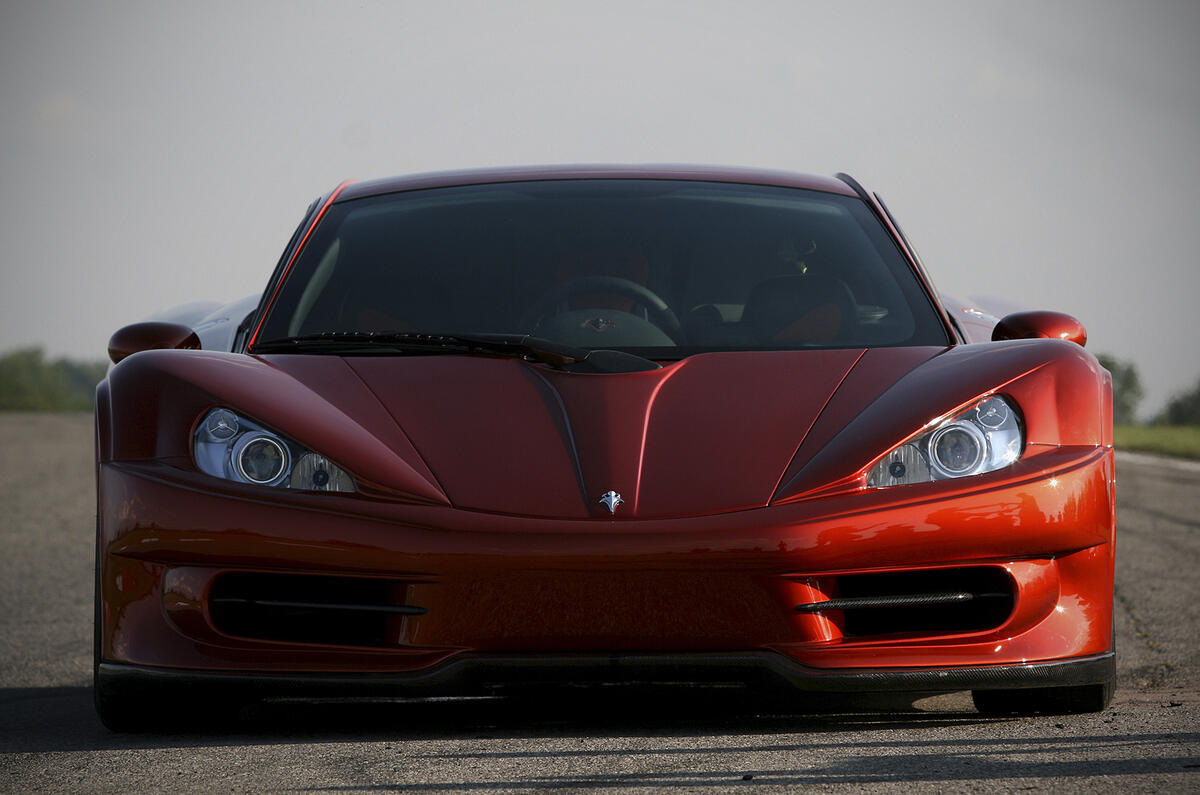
[337,163,858,202]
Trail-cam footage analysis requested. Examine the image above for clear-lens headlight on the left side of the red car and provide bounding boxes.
[192,408,355,491]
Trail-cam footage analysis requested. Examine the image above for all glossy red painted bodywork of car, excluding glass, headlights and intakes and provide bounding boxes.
[96,167,1114,710]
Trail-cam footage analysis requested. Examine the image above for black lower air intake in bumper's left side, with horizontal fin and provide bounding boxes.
[209,572,426,646]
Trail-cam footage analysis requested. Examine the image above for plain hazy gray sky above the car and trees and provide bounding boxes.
[0,0,1200,413]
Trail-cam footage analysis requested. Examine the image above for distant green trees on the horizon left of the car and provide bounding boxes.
[0,348,108,411]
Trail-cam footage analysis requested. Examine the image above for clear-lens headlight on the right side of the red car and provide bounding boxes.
[866,395,1025,489]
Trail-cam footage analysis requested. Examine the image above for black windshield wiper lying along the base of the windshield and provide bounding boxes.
[251,331,661,372]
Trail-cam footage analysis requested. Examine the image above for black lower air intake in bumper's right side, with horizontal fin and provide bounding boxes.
[796,566,1015,638]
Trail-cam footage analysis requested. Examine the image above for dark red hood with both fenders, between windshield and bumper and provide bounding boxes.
[103,340,1111,521]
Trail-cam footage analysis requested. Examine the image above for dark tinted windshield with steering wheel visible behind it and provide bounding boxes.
[258,179,948,359]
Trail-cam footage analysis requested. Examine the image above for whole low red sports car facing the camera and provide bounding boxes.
[96,167,1114,729]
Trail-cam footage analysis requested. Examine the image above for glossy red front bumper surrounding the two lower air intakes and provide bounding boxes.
[98,448,1112,689]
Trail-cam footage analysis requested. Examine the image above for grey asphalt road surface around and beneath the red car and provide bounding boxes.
[0,414,1200,793]
